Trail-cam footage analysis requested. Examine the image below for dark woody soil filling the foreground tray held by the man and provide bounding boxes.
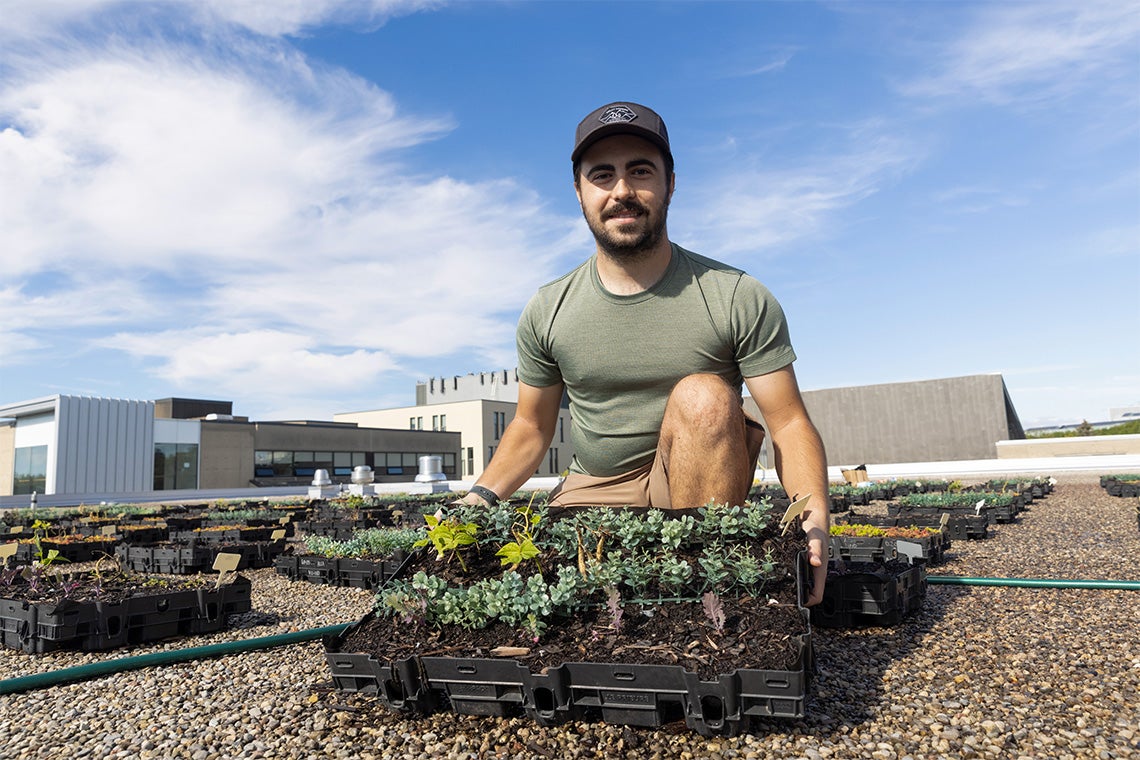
[339,510,809,680]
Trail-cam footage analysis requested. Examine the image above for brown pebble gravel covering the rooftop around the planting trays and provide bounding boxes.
[0,474,1140,760]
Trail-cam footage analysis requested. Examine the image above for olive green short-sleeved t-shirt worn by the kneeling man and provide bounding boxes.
[516,244,796,476]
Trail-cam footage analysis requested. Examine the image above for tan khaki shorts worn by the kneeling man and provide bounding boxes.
[547,415,764,509]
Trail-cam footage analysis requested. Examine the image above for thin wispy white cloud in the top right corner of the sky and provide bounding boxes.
[902,0,1140,103]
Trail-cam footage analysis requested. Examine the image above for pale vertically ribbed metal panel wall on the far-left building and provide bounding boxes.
[55,395,154,493]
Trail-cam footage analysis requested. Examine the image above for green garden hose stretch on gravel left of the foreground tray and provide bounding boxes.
[0,623,351,694]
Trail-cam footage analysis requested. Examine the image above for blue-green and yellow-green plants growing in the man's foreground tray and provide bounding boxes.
[377,501,779,638]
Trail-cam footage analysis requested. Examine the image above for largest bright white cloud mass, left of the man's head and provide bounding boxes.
[0,17,579,410]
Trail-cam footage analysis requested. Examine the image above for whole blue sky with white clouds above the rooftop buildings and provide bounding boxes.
[0,0,1140,426]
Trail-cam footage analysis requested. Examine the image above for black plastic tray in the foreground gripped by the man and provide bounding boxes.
[325,610,812,736]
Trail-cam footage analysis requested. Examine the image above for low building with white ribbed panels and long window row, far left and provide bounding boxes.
[0,395,459,496]
